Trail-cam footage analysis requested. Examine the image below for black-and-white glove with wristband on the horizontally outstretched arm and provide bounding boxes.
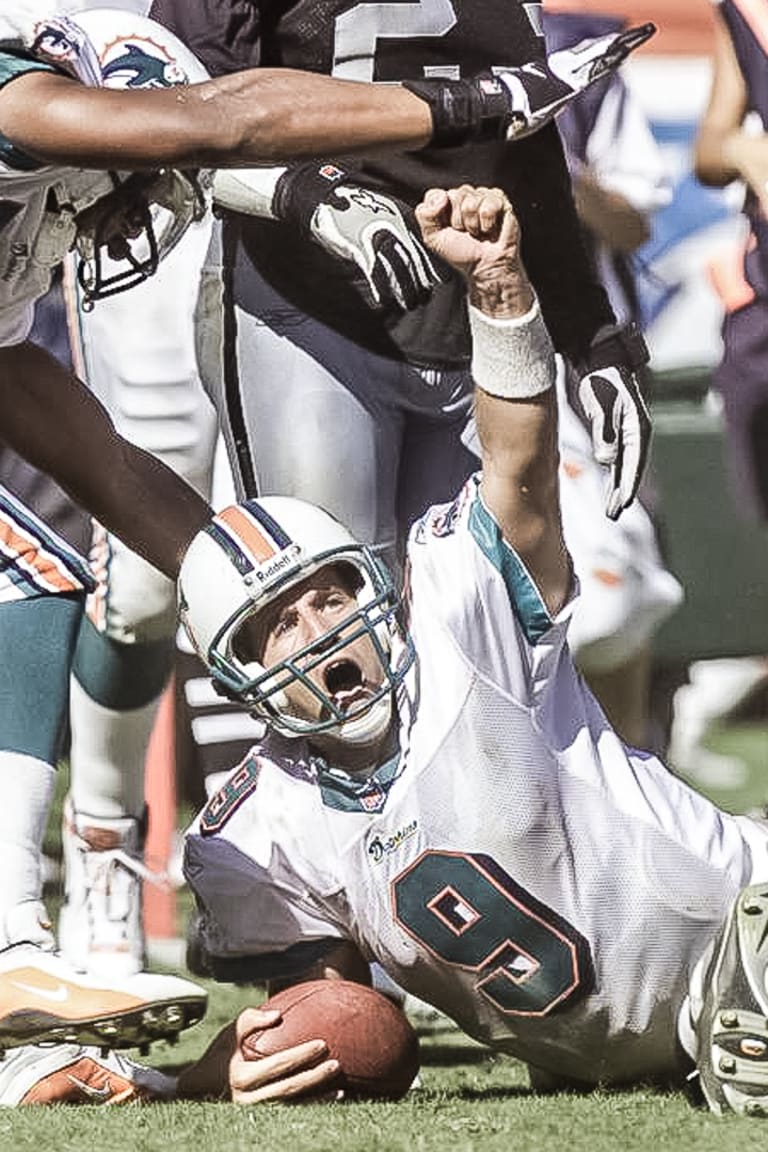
[403,23,656,146]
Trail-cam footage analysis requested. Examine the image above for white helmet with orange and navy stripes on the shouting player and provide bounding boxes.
[178,497,413,745]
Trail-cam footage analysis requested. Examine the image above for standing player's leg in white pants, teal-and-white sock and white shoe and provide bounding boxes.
[60,216,215,975]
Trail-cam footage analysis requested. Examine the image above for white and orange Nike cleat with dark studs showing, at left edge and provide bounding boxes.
[0,943,207,1048]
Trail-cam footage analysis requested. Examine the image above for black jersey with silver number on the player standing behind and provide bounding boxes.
[151,0,613,366]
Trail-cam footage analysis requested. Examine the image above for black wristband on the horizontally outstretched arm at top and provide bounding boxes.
[403,76,510,147]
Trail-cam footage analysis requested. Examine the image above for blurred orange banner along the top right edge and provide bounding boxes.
[545,0,715,55]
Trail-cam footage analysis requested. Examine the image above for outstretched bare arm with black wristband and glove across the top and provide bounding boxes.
[0,24,653,170]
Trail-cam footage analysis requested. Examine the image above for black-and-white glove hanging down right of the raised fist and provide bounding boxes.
[579,324,651,520]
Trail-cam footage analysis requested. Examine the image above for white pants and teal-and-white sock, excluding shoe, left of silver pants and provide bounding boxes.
[71,220,216,817]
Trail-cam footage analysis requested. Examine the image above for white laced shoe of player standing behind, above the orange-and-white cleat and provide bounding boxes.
[59,796,151,980]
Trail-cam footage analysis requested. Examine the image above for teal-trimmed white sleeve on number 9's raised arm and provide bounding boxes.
[409,476,578,706]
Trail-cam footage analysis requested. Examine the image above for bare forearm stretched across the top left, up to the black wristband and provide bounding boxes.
[0,69,432,169]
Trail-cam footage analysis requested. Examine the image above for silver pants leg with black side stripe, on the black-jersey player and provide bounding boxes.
[207,245,403,551]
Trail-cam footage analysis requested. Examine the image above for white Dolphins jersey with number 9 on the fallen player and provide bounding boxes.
[185,478,768,1083]
